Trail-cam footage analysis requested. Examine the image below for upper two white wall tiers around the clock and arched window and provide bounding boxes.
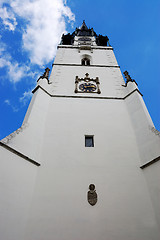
[49,46,124,97]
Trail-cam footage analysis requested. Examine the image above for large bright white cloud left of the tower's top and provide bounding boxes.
[1,0,75,65]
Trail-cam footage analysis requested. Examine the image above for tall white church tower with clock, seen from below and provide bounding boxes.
[0,22,160,240]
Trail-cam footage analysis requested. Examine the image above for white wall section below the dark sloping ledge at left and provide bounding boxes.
[0,147,37,240]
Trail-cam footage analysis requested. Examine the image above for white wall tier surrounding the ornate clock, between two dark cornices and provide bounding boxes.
[50,65,124,97]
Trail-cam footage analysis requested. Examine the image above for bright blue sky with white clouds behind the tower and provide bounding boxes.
[0,0,160,138]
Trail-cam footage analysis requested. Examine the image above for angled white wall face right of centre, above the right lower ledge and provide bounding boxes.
[125,92,160,164]
